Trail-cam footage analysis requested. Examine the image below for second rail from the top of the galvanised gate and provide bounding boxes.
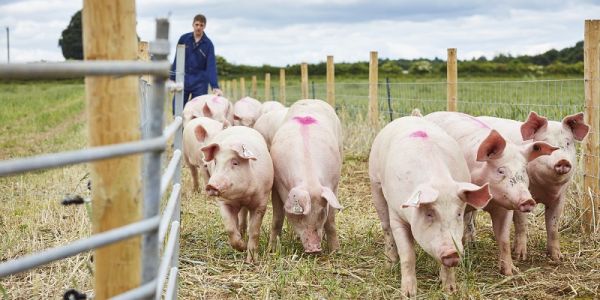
[0,137,166,176]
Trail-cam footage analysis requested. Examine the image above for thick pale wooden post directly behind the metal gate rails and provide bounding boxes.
[82,0,142,299]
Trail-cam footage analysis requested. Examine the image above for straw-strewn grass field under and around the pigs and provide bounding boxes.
[0,80,600,299]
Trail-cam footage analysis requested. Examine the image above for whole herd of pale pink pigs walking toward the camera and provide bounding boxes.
[183,95,589,296]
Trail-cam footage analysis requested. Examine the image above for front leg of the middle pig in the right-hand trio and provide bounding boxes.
[485,204,516,275]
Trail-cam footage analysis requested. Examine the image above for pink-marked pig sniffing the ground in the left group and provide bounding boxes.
[269,99,342,254]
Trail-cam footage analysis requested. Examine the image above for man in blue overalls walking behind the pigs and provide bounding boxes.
[170,15,222,112]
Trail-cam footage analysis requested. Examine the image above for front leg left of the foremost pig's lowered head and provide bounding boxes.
[390,220,417,297]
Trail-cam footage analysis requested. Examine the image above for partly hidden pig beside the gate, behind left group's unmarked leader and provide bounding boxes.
[183,117,225,191]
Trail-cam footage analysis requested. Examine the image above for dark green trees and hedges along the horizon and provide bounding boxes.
[58,11,583,78]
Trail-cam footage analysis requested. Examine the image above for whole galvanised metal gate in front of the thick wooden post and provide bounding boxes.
[0,19,185,299]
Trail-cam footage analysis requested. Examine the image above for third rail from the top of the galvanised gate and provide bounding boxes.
[0,216,160,277]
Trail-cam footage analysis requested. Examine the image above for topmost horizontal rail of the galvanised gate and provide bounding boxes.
[0,60,171,79]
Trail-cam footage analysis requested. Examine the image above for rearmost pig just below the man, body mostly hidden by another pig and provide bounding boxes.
[182,94,233,127]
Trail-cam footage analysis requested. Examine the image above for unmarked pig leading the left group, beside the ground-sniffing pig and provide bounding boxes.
[201,126,273,263]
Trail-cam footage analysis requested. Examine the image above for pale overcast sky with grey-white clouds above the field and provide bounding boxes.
[0,0,600,66]
